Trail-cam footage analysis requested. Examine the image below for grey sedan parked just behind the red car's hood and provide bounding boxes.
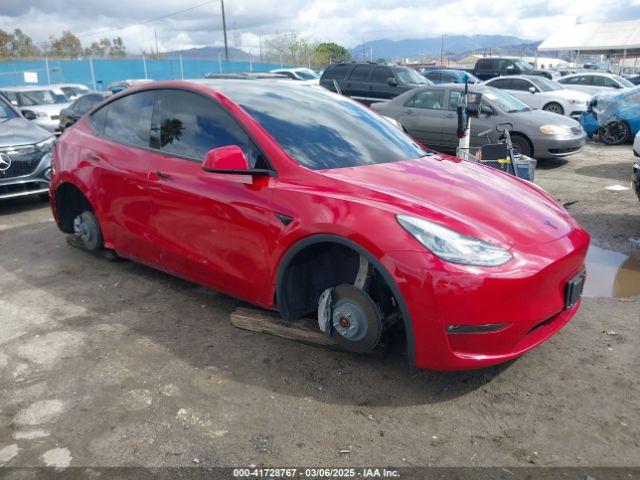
[371,84,586,159]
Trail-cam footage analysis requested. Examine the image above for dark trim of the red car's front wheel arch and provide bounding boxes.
[275,234,415,367]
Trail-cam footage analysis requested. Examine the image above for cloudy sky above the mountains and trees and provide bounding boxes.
[0,0,640,53]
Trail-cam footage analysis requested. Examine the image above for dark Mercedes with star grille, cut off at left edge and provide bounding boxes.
[0,95,56,199]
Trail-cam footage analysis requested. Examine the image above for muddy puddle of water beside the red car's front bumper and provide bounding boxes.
[582,245,640,298]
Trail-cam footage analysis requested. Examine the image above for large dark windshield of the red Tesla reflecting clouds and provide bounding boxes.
[214,81,427,170]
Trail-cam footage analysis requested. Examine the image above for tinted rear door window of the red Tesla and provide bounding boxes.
[104,90,156,147]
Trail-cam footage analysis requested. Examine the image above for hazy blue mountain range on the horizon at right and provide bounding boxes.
[349,35,532,60]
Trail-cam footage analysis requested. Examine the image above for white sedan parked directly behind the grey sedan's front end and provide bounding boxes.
[486,75,591,119]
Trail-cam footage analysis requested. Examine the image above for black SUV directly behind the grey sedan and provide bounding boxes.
[320,63,432,105]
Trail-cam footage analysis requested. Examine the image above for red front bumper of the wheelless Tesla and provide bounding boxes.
[387,228,589,370]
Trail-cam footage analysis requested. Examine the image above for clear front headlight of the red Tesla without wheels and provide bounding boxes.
[397,215,513,267]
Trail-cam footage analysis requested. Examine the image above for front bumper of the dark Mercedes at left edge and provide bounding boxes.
[0,153,51,200]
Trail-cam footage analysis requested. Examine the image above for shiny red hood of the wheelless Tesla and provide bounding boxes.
[318,155,577,247]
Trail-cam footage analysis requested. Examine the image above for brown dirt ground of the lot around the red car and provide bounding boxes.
[0,145,640,466]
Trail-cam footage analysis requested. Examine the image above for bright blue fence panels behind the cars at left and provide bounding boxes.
[0,58,280,90]
